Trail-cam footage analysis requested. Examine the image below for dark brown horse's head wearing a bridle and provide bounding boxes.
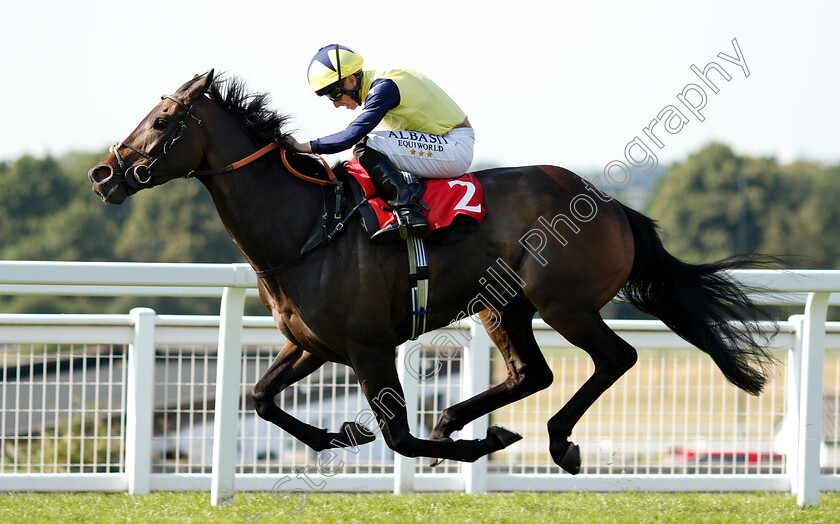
[88,69,213,204]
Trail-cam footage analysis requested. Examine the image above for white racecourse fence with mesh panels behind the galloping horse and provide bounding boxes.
[0,262,840,505]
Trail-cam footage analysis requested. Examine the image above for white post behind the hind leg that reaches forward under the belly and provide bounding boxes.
[461,320,490,493]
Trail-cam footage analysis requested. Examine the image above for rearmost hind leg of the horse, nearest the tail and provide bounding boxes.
[543,312,637,475]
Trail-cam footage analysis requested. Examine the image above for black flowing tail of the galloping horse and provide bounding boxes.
[622,206,777,395]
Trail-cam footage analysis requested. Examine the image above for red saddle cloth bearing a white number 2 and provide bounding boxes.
[346,160,487,236]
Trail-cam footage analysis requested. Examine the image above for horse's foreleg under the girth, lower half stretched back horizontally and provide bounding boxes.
[350,348,518,462]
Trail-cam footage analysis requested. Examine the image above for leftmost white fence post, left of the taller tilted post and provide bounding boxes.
[125,308,155,495]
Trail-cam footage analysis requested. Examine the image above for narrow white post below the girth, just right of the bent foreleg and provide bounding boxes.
[394,342,421,495]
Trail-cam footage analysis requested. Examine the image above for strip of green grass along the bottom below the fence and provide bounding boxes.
[0,492,840,524]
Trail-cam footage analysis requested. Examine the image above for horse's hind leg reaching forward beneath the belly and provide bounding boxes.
[430,304,554,440]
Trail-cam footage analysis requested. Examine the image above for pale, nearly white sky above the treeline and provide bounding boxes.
[0,0,840,173]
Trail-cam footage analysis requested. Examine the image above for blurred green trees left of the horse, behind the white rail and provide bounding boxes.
[0,151,249,314]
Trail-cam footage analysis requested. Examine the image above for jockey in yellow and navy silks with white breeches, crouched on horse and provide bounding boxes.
[292,44,475,243]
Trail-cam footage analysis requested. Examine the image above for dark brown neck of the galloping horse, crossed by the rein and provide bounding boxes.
[201,104,323,270]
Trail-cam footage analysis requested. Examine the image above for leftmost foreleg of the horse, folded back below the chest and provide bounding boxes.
[251,342,375,451]
